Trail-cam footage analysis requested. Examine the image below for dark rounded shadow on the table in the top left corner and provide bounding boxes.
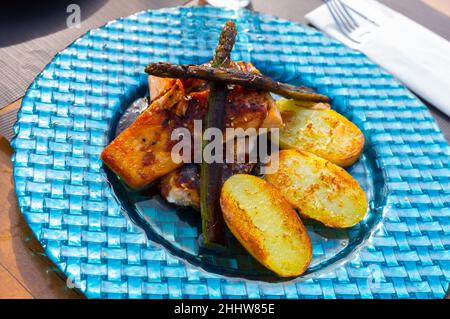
[0,0,107,48]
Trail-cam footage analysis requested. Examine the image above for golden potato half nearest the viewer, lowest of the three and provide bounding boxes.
[220,174,312,277]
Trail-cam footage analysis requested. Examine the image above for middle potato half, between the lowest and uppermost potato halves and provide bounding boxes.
[265,150,367,228]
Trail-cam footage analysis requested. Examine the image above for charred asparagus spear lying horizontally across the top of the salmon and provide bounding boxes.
[145,61,329,102]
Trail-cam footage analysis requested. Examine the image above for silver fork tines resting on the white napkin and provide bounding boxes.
[323,0,379,43]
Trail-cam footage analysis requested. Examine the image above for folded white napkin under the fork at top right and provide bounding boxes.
[305,0,450,116]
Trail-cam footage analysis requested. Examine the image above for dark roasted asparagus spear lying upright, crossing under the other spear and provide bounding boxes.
[200,21,237,247]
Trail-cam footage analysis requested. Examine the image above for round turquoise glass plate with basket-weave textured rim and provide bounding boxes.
[13,7,450,298]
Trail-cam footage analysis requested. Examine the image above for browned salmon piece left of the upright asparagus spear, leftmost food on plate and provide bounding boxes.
[100,80,207,189]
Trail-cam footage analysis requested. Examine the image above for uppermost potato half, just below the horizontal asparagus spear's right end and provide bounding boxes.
[277,100,364,167]
